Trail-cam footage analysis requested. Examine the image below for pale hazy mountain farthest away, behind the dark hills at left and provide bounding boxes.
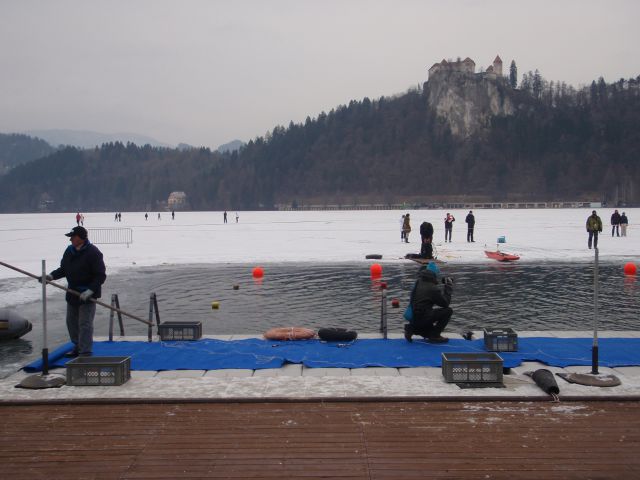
[25,129,171,148]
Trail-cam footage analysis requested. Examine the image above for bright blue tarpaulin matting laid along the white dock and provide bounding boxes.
[25,337,640,372]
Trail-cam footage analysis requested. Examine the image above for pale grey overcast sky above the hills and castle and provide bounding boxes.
[0,0,640,147]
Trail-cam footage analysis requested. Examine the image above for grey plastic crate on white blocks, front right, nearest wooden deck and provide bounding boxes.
[442,353,503,384]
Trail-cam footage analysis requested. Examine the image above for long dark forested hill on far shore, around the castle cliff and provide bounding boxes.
[0,77,640,212]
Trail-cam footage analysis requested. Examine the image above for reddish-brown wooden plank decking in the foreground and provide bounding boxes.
[0,401,640,480]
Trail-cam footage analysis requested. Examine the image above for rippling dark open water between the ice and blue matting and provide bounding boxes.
[0,261,640,378]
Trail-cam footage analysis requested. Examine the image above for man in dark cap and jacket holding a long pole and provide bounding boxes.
[42,227,107,357]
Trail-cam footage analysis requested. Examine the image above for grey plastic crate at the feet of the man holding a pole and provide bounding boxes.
[66,357,131,387]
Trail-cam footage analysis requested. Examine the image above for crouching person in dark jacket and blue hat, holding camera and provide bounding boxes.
[404,265,453,343]
